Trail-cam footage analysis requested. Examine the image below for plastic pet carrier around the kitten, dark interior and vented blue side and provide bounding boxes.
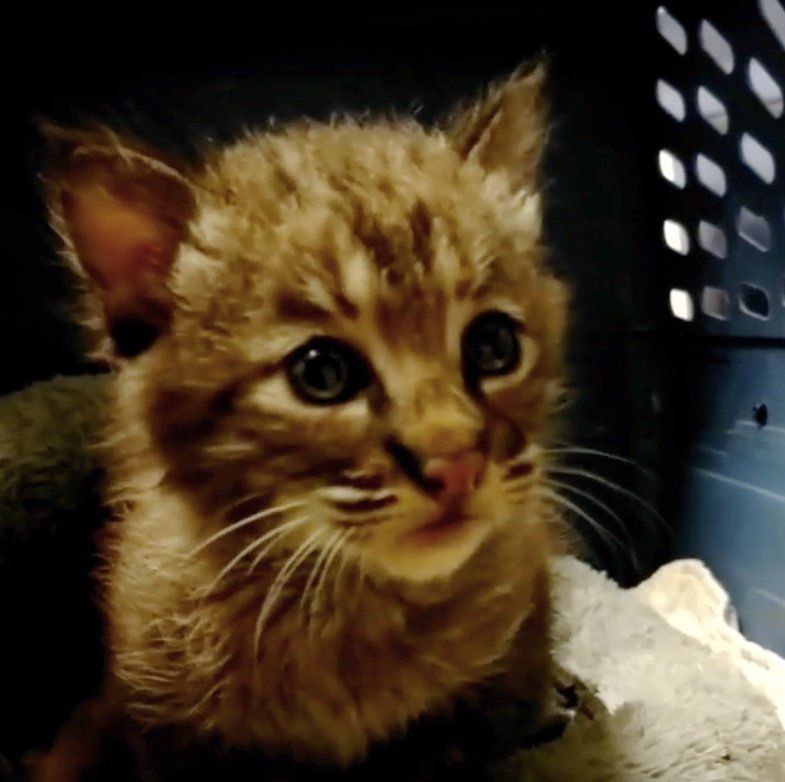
[0,10,785,764]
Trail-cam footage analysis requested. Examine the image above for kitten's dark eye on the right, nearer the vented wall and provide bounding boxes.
[463,311,521,377]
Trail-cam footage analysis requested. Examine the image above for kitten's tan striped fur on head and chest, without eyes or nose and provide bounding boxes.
[39,66,565,764]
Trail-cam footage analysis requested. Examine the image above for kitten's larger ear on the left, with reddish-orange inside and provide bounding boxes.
[41,125,194,356]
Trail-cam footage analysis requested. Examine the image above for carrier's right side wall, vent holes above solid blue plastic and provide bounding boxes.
[651,0,785,653]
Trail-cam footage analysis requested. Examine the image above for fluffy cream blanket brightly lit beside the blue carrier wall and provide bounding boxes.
[512,558,785,782]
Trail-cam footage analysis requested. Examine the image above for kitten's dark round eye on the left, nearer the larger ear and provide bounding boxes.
[287,337,370,405]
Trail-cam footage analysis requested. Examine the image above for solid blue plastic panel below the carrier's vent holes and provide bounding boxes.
[678,348,785,654]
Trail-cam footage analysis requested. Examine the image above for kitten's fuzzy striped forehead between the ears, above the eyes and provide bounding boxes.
[196,122,539,334]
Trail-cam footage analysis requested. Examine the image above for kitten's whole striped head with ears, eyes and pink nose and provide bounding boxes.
[43,64,565,581]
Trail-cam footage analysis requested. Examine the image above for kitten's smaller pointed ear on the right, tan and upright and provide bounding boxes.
[445,61,547,192]
